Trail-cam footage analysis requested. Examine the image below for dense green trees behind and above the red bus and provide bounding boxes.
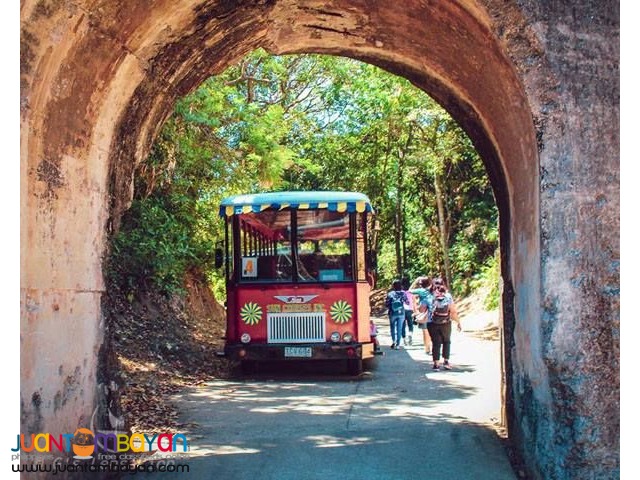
[109,51,499,304]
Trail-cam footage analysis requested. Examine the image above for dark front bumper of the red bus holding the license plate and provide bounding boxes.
[224,342,374,361]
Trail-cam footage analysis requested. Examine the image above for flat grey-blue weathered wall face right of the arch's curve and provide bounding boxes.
[504,1,620,479]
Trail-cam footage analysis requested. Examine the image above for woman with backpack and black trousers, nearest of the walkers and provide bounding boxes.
[427,278,462,371]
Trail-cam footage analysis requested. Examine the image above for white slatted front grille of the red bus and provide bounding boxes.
[267,313,326,343]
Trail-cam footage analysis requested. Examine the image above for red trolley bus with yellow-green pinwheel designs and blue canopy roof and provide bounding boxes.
[220,192,374,374]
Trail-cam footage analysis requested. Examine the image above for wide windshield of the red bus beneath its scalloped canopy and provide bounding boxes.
[219,194,366,283]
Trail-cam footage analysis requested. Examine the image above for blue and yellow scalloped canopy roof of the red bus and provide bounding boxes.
[220,192,373,217]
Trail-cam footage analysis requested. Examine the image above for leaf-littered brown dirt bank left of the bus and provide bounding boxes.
[99,272,230,433]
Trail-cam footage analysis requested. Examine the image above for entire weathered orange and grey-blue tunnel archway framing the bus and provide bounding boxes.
[21,0,619,478]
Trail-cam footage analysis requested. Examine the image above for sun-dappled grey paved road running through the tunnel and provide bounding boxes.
[152,319,516,480]
